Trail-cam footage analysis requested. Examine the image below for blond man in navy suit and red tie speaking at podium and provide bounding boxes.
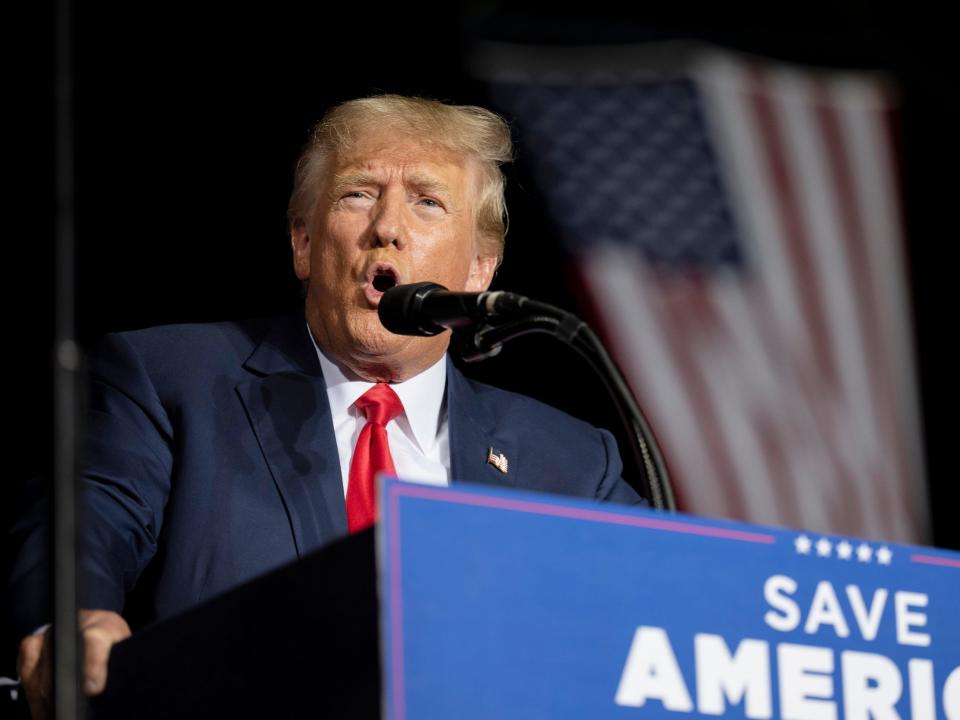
[17,96,639,713]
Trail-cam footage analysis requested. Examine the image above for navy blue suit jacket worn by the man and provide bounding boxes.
[7,315,639,636]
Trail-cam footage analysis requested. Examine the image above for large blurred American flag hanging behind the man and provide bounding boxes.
[488,43,929,543]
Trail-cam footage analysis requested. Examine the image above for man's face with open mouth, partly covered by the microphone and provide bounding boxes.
[291,130,496,380]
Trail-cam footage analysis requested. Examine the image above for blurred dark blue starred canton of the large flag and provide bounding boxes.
[493,80,744,271]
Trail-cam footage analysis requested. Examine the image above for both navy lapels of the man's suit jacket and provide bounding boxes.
[237,324,523,557]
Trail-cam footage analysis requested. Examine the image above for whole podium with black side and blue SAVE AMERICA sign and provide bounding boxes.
[93,481,960,720]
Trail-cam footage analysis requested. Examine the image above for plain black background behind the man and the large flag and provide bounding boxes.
[0,2,960,612]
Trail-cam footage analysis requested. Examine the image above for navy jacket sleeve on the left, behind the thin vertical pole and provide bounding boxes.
[5,335,172,641]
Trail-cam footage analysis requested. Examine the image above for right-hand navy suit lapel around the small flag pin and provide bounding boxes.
[447,366,523,487]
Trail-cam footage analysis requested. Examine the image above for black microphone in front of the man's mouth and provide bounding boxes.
[377,282,527,337]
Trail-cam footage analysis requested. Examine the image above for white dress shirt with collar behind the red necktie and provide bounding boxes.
[308,328,450,497]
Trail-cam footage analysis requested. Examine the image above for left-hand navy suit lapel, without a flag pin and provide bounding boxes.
[237,315,347,557]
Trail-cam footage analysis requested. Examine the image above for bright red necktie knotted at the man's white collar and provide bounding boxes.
[347,383,403,533]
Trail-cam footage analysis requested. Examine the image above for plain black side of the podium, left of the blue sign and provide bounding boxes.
[91,529,381,720]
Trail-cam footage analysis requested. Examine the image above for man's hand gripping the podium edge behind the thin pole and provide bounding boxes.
[17,610,130,719]
